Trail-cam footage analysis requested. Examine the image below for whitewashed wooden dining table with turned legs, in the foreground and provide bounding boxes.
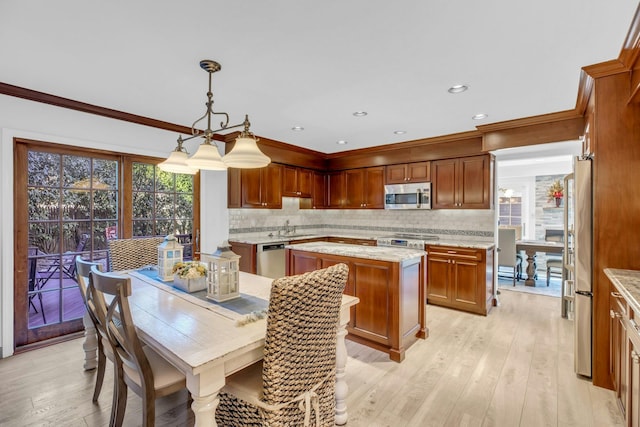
[83,270,359,427]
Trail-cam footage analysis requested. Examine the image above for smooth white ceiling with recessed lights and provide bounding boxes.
[0,0,637,153]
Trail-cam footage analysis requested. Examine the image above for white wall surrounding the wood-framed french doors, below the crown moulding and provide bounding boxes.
[0,95,229,357]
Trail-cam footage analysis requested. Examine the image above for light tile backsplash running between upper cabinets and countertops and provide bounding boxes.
[229,197,496,241]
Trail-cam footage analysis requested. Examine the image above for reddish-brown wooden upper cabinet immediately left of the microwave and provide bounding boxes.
[343,166,384,209]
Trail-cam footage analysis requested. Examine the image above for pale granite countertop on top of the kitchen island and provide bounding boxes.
[286,242,426,262]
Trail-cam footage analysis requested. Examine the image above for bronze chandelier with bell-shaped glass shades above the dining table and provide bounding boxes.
[158,59,271,175]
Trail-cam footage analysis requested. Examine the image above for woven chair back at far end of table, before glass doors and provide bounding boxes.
[107,237,164,271]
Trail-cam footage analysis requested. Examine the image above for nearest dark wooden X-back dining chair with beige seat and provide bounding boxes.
[89,267,186,427]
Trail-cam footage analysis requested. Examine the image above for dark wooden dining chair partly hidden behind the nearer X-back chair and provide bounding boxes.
[75,256,114,402]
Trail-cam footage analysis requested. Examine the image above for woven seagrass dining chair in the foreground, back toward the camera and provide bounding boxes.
[216,264,349,427]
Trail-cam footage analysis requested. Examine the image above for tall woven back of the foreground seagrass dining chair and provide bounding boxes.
[262,264,349,426]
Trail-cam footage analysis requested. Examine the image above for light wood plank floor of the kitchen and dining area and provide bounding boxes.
[0,290,623,427]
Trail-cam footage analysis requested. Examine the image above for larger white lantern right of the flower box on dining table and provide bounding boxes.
[201,242,240,302]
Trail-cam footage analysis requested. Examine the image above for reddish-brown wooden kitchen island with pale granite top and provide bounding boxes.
[285,242,428,362]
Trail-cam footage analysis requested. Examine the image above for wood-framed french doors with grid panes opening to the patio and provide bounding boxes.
[14,139,199,349]
